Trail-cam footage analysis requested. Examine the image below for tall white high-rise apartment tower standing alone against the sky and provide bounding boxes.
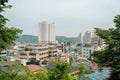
[38,21,56,43]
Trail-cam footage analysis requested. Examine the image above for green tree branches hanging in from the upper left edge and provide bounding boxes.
[0,0,22,52]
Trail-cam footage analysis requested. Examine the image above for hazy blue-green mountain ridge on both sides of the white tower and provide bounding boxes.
[16,35,76,43]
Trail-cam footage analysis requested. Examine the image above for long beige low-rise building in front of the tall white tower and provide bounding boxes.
[19,46,57,61]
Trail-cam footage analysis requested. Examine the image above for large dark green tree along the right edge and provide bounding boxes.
[93,15,120,80]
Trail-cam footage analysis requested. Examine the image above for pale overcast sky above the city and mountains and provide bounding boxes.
[5,0,120,37]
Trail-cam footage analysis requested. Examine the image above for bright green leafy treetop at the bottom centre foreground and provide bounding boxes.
[48,60,73,80]
